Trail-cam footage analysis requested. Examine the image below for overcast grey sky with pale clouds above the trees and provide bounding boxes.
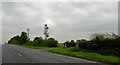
[2,2,118,42]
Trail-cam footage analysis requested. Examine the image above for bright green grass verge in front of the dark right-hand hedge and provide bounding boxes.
[48,48,120,65]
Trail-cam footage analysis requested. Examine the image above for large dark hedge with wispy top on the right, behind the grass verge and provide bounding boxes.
[77,33,120,56]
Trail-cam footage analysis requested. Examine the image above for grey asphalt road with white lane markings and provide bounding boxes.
[2,44,104,63]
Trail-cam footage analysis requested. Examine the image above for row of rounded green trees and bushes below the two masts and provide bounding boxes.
[8,32,58,47]
